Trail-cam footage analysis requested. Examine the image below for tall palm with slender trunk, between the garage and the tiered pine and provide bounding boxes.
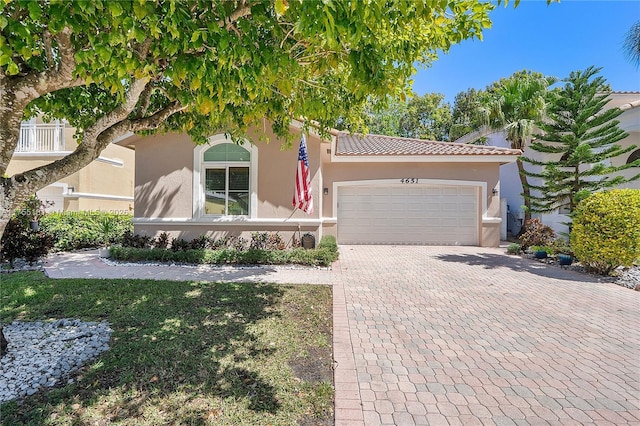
[478,70,556,221]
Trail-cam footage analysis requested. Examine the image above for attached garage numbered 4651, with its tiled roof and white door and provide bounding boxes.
[322,132,521,247]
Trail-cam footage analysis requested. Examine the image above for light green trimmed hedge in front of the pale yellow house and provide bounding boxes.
[40,211,133,251]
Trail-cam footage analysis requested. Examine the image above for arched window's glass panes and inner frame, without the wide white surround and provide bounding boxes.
[201,143,251,216]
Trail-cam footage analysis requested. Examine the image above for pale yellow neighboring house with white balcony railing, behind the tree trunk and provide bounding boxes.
[7,119,135,212]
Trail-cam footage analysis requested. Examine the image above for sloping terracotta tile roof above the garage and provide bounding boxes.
[336,132,521,157]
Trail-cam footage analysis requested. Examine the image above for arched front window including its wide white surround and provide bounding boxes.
[194,135,257,218]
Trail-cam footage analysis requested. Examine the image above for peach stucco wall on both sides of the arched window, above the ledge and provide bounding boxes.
[135,125,328,219]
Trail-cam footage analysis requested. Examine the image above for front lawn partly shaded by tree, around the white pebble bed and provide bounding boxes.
[0,272,333,425]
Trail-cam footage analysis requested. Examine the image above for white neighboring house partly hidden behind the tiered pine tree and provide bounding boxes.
[488,92,640,238]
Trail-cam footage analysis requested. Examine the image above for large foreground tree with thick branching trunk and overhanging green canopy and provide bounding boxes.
[0,0,510,352]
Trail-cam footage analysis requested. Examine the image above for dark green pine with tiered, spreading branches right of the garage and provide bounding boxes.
[523,67,640,213]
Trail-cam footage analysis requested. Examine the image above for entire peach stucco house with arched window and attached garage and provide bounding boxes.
[118,123,520,246]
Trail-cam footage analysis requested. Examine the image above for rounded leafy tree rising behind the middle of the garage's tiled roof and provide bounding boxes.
[398,93,451,141]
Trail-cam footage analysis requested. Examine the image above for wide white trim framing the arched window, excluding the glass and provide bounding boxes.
[192,133,258,222]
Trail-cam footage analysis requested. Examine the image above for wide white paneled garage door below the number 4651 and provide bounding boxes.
[338,184,479,245]
